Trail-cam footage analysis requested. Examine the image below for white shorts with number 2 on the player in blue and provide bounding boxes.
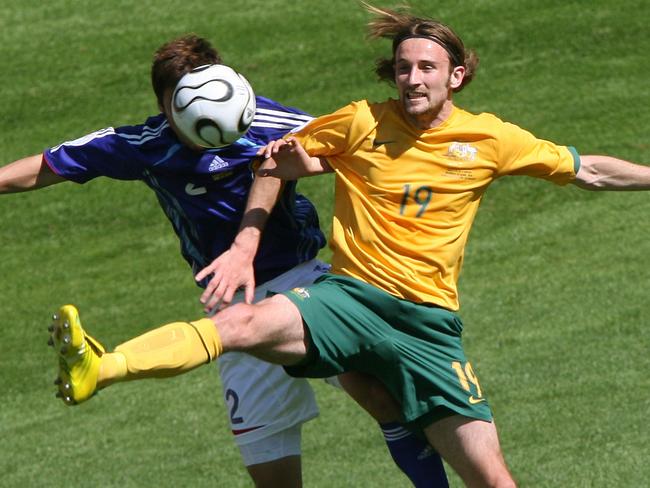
[209,259,329,466]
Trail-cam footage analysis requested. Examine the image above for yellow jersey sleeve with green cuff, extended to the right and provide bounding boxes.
[498,122,580,185]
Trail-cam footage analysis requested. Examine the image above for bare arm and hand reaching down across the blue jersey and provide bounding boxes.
[196,170,283,312]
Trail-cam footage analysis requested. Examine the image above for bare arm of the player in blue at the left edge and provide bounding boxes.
[0,154,67,193]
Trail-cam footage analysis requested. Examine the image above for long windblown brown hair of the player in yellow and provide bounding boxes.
[361,2,478,92]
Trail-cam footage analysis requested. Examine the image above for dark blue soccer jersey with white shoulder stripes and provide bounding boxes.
[44,97,325,284]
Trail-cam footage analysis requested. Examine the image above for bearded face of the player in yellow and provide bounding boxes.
[395,38,465,129]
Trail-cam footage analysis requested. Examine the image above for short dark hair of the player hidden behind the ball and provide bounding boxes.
[151,34,222,105]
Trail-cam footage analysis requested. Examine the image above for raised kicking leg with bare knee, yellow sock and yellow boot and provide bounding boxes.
[50,295,307,404]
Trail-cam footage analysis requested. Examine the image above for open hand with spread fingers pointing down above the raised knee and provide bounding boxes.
[195,244,255,314]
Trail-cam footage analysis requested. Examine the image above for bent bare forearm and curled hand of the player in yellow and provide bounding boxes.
[257,137,333,180]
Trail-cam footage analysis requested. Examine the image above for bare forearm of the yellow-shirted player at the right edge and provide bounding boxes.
[574,155,650,191]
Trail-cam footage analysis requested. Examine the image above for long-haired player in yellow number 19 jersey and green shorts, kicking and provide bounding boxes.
[48,6,650,487]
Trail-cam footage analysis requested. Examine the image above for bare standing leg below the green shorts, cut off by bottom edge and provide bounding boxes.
[424,415,516,488]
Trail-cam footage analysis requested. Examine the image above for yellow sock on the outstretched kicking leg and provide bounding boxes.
[97,318,223,388]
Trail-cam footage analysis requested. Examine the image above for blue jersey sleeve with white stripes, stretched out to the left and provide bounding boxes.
[43,127,142,183]
